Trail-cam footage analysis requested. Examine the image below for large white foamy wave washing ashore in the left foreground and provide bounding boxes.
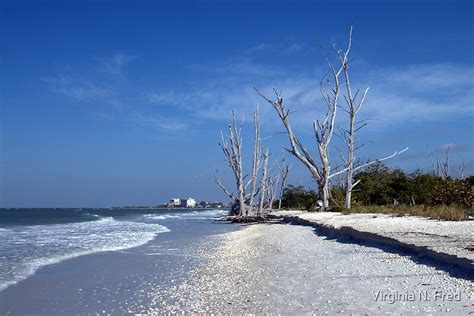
[0,217,169,291]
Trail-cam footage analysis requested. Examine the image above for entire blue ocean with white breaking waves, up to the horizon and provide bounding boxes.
[0,208,227,291]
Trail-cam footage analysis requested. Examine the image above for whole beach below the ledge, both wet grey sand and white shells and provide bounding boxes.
[0,215,474,315]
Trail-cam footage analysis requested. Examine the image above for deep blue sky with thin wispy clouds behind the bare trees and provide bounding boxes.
[0,0,474,207]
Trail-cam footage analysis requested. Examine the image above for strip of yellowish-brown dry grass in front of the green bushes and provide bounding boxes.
[342,205,474,221]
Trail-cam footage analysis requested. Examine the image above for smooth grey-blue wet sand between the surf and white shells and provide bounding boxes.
[0,216,238,315]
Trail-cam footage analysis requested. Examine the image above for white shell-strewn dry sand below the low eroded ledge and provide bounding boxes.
[149,224,474,314]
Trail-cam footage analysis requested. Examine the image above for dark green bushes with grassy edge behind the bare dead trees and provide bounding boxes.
[282,163,474,220]
